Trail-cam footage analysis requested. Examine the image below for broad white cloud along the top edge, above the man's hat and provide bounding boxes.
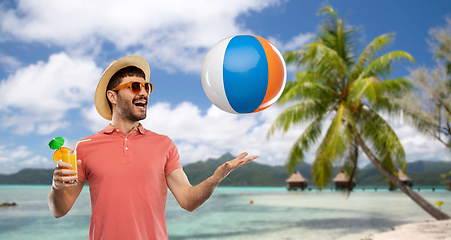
[0,0,279,71]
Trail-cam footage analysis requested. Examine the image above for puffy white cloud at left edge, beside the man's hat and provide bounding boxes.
[0,53,101,134]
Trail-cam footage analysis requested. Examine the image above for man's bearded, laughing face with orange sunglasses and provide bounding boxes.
[117,77,149,122]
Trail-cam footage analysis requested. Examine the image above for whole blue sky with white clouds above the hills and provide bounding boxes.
[0,0,451,173]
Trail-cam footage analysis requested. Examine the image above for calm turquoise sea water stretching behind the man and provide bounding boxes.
[0,185,451,240]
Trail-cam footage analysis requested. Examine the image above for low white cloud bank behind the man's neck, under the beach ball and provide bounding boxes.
[83,99,308,165]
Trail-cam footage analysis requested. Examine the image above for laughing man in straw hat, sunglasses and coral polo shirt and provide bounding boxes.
[48,56,257,239]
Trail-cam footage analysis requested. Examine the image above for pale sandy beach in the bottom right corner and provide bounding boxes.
[364,220,451,240]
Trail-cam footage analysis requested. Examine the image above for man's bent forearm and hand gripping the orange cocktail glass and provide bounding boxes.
[47,160,85,218]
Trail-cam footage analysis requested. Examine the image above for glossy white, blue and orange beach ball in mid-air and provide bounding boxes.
[201,35,287,114]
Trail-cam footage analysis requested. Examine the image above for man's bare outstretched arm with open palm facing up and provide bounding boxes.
[166,153,258,212]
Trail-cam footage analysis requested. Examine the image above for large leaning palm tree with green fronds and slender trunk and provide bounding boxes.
[268,5,450,220]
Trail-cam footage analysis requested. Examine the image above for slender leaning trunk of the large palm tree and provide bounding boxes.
[355,132,451,220]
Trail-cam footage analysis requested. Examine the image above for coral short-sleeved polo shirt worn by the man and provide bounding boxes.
[77,124,182,240]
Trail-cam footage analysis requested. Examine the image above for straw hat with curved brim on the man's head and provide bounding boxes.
[94,55,150,120]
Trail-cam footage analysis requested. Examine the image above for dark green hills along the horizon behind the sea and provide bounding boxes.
[0,153,451,186]
